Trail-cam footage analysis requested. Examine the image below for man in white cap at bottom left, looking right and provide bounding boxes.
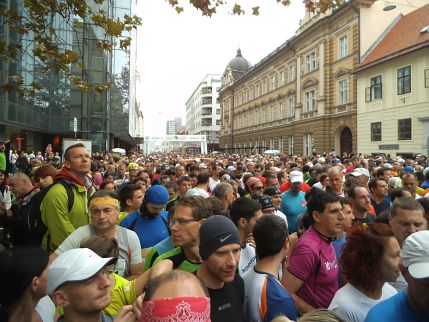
[48,248,116,322]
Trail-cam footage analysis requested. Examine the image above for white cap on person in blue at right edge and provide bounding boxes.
[401,230,429,278]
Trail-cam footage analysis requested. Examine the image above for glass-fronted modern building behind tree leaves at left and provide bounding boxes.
[0,0,143,151]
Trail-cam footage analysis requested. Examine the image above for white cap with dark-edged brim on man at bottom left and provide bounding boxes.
[47,248,117,294]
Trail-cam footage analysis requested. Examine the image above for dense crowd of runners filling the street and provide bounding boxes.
[0,142,429,322]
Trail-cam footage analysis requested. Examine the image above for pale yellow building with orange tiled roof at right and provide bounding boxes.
[356,4,429,157]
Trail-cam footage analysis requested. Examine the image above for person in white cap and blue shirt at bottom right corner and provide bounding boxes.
[365,230,429,322]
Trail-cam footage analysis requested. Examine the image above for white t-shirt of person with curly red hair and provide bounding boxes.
[328,283,398,322]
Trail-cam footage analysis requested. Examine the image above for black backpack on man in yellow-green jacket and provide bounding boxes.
[29,179,74,252]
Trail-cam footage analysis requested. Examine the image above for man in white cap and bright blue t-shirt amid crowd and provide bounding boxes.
[281,170,307,233]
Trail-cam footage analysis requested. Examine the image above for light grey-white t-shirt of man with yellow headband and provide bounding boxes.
[55,225,143,277]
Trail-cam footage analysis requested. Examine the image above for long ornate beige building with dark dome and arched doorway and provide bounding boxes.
[219,1,363,155]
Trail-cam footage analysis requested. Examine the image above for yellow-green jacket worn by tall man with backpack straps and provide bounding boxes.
[40,182,95,253]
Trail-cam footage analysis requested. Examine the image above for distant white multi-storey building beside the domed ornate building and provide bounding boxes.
[186,74,222,151]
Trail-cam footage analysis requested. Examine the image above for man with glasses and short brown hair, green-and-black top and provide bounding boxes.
[154,196,209,273]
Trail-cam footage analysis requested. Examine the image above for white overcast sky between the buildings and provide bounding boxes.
[137,0,304,135]
